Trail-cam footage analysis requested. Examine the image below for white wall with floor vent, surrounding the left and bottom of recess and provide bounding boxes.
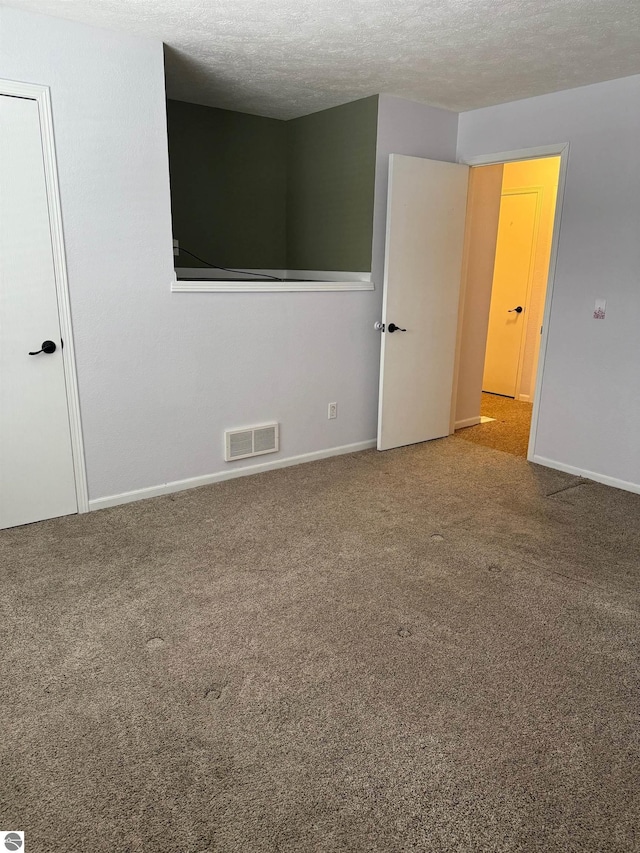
[0,8,379,501]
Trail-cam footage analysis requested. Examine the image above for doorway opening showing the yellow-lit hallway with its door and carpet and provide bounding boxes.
[455,156,561,458]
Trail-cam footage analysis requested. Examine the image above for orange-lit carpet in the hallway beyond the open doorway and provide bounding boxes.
[456,393,533,459]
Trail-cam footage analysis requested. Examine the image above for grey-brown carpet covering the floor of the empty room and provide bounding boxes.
[0,437,640,853]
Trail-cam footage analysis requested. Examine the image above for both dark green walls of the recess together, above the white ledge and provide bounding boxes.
[167,95,378,271]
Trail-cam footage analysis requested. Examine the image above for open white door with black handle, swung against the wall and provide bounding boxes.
[378,154,469,450]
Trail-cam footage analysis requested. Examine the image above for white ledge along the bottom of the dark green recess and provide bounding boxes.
[171,269,375,293]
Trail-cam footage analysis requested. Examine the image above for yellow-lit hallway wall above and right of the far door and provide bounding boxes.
[502,157,560,402]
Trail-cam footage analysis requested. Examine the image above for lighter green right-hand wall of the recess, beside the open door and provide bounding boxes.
[287,95,378,272]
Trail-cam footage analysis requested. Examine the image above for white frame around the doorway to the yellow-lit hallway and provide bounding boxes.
[454,142,569,462]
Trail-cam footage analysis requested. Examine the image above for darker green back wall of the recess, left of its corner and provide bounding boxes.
[167,101,286,269]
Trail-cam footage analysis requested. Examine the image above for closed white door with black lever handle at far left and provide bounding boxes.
[0,95,78,528]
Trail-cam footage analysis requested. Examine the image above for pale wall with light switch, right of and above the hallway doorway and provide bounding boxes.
[458,76,640,490]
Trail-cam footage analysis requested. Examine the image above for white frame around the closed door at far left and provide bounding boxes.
[0,79,89,513]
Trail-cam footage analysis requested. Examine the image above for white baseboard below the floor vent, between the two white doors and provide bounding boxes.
[89,439,376,512]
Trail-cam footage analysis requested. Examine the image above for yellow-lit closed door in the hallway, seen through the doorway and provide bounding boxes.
[482,192,538,397]
